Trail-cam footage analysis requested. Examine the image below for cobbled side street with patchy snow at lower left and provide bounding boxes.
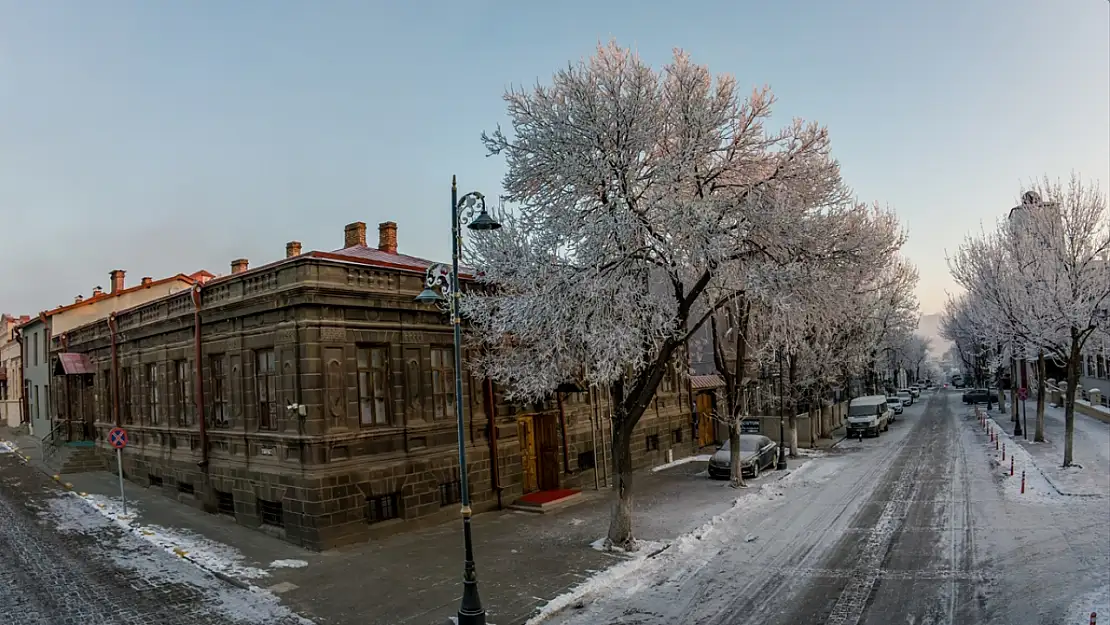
[0,453,311,625]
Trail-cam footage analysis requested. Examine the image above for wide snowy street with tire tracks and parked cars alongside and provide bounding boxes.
[541,393,1110,625]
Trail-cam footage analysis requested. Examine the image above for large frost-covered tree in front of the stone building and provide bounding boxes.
[463,44,876,547]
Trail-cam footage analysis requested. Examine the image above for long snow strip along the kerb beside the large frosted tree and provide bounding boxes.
[526,461,815,625]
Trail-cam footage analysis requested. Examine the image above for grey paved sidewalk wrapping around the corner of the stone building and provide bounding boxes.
[0,433,816,625]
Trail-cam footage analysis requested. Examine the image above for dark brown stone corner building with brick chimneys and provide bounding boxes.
[52,222,692,550]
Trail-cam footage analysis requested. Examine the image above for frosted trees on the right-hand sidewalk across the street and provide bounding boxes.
[941,174,1110,466]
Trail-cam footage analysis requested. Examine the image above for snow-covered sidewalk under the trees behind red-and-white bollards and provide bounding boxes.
[991,400,1110,497]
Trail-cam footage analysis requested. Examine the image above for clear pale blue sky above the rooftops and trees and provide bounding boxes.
[0,0,1110,313]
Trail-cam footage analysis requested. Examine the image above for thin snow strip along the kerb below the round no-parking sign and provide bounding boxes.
[67,493,269,579]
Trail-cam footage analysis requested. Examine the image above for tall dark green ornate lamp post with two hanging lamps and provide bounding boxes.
[416,172,501,625]
